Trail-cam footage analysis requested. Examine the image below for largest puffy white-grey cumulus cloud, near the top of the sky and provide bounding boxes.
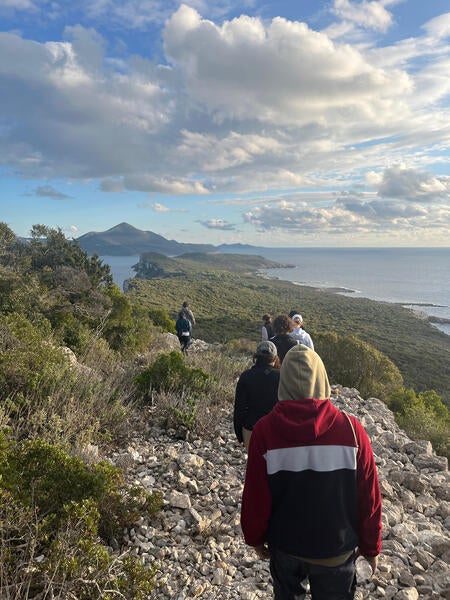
[164,5,412,125]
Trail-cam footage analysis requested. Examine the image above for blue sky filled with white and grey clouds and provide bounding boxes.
[0,0,450,247]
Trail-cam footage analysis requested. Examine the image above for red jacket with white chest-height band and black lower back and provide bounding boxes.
[241,399,381,559]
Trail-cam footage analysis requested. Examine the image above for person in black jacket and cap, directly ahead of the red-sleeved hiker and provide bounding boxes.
[233,340,280,450]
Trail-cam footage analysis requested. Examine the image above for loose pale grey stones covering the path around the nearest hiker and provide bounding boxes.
[107,386,450,600]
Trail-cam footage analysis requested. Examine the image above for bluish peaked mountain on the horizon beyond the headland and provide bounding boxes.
[77,223,218,256]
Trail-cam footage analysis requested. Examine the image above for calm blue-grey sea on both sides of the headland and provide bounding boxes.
[101,248,450,335]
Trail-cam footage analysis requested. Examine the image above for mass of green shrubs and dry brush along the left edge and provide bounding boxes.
[0,223,162,599]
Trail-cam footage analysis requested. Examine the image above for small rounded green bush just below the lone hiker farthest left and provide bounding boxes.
[135,350,210,401]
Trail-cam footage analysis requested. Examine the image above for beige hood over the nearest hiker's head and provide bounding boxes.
[278,344,331,400]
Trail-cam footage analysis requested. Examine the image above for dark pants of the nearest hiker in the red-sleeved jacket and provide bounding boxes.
[270,548,356,600]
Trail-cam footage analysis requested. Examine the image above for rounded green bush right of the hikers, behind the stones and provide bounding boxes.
[314,333,403,400]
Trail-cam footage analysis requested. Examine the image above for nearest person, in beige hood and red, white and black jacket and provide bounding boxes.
[241,344,381,600]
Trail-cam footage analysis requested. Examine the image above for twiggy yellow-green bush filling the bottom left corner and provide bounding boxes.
[0,488,155,600]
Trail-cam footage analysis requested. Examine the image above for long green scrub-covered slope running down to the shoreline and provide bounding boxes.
[129,255,450,405]
